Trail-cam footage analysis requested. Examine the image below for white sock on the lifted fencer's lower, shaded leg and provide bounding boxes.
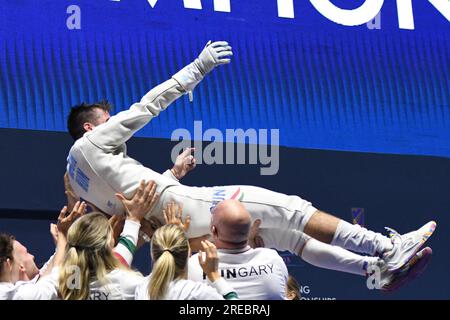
[301,238,379,276]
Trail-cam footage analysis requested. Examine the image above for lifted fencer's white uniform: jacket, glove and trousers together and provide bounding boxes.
[67,42,316,252]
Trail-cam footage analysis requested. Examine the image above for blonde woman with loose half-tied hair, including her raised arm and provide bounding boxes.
[58,181,158,300]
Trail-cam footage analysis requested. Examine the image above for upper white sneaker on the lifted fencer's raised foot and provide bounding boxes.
[381,221,436,273]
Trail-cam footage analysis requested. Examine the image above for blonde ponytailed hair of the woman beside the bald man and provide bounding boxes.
[148,224,189,300]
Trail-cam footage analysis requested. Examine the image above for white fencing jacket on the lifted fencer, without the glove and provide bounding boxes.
[67,79,185,215]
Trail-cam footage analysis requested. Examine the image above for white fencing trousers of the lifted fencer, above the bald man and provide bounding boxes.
[153,185,317,249]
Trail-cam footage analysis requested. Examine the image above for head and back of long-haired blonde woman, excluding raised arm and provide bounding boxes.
[58,212,142,300]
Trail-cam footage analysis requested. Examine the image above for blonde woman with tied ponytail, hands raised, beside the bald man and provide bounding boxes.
[136,205,237,300]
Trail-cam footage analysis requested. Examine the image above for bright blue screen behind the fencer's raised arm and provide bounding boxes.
[0,0,450,157]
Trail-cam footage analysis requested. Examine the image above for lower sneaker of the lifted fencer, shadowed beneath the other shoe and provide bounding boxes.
[381,247,433,292]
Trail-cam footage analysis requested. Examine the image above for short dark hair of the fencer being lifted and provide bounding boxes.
[67,100,111,140]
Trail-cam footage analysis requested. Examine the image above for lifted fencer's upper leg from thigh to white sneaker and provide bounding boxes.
[230,186,436,271]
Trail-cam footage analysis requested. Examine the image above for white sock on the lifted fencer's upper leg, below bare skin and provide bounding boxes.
[331,220,393,256]
